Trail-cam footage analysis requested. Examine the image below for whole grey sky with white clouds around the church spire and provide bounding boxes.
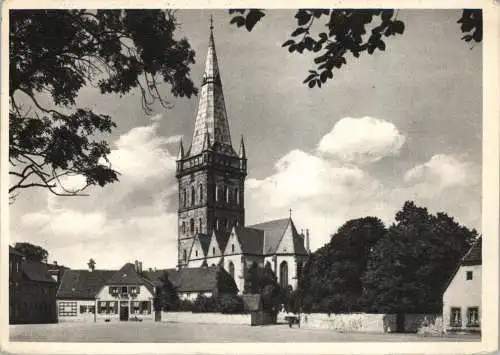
[10,10,482,269]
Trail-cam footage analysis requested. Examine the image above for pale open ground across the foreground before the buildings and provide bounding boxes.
[10,322,480,343]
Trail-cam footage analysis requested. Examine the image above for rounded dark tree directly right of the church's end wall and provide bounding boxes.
[298,217,386,312]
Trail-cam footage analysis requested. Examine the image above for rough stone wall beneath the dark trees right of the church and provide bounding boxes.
[300,313,396,333]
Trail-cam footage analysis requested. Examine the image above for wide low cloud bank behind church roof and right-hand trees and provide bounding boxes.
[245,131,481,249]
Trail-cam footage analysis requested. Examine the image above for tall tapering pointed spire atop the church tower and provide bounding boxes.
[189,18,231,156]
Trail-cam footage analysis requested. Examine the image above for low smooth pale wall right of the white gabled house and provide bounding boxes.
[161,312,251,325]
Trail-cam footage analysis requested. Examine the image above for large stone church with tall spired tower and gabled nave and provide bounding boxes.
[176,25,309,293]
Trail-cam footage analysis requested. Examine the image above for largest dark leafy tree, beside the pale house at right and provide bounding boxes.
[362,202,477,313]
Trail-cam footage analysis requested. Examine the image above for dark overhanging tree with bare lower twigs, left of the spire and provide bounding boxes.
[9,9,197,198]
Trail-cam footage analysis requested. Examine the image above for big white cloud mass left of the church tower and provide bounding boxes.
[11,116,178,268]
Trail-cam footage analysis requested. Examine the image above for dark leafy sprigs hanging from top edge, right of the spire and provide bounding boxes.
[229,9,483,88]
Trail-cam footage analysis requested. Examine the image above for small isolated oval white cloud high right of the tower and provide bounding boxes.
[317,117,405,164]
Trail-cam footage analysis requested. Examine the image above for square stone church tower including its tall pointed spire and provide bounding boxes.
[176,22,247,267]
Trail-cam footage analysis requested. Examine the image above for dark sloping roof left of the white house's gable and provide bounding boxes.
[57,269,116,299]
